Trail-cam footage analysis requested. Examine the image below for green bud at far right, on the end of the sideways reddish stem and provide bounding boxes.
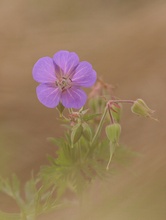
[131,99,154,118]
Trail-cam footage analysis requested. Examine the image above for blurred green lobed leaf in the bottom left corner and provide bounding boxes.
[0,174,60,220]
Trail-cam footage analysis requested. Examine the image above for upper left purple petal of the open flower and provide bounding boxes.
[32,57,56,83]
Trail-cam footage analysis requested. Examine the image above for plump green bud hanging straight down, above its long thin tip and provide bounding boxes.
[106,123,121,144]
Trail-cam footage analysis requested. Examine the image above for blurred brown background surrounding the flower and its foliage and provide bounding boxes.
[0,0,166,220]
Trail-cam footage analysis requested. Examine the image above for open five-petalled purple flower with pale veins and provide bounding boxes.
[33,50,96,109]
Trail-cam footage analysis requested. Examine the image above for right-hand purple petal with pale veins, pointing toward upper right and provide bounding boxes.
[72,61,97,87]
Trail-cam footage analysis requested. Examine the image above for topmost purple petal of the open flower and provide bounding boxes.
[53,50,79,74]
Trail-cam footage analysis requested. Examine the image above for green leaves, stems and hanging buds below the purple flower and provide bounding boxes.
[0,80,154,220]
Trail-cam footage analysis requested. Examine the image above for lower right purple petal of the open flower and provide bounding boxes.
[61,87,87,109]
